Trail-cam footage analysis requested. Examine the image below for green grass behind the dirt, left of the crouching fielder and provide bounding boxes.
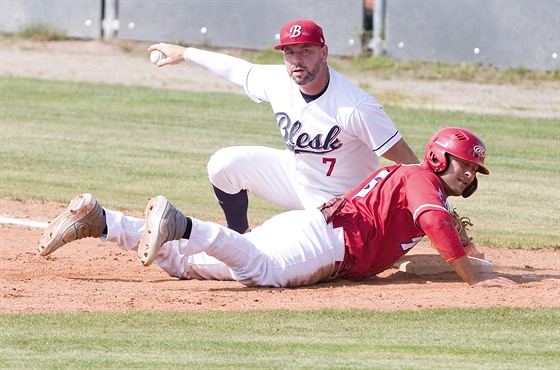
[0,79,282,223]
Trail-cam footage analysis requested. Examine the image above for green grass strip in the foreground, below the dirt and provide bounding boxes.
[0,308,560,369]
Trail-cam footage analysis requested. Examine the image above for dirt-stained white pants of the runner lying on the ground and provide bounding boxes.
[101,209,345,287]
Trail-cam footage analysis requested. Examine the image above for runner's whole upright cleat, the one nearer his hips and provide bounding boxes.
[138,195,187,266]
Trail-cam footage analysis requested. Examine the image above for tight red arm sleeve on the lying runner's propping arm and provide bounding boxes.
[417,210,467,263]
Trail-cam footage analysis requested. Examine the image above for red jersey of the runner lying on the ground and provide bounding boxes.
[333,164,465,280]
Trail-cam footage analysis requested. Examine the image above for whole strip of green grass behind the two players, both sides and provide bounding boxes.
[0,78,560,248]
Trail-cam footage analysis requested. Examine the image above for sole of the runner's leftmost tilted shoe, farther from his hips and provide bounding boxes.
[38,194,97,256]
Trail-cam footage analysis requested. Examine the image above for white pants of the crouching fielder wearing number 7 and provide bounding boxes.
[208,146,334,210]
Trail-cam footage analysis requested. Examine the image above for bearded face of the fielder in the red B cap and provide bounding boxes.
[284,44,326,86]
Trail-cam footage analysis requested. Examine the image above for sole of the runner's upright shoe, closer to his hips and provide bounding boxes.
[138,195,169,266]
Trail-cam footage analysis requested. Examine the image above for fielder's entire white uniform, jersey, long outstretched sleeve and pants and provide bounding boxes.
[184,48,402,209]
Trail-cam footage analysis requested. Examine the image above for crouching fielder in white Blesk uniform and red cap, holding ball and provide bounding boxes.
[148,19,418,233]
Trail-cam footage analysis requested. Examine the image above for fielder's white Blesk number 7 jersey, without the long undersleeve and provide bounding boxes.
[244,65,401,194]
